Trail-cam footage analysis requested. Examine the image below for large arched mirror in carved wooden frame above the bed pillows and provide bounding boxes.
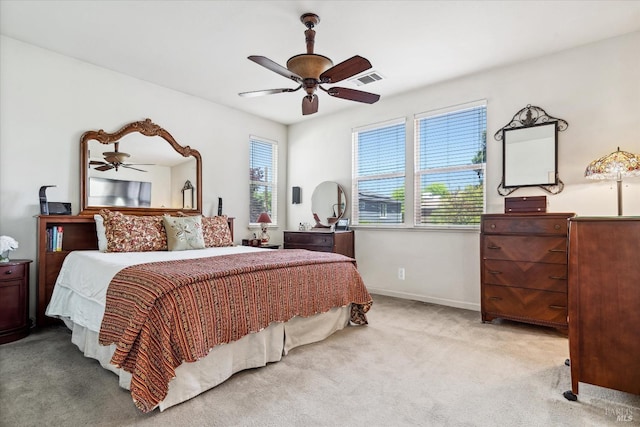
[80,119,202,215]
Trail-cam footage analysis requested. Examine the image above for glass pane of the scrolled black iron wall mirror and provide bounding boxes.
[502,122,558,188]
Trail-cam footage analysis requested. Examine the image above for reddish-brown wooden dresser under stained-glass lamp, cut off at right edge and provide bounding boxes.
[565,217,640,400]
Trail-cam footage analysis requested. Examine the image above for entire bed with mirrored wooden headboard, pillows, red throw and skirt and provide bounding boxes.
[42,119,371,412]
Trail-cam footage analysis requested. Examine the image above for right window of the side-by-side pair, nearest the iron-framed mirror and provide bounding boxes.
[414,101,487,226]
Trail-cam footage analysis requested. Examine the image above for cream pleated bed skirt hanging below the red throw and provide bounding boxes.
[63,306,351,411]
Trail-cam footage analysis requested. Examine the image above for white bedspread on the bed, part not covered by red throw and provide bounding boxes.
[45,246,269,332]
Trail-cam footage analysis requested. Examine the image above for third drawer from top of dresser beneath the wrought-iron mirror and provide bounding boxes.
[482,259,567,293]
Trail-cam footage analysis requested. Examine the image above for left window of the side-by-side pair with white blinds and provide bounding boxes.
[351,119,406,225]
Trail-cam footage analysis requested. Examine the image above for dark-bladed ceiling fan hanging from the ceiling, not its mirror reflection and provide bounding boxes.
[239,13,380,115]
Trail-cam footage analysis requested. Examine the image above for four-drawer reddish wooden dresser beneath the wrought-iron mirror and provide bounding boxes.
[480,213,574,333]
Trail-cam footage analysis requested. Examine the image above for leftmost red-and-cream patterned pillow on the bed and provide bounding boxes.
[100,209,167,252]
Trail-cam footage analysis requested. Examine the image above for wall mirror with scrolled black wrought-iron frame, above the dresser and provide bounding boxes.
[494,105,569,196]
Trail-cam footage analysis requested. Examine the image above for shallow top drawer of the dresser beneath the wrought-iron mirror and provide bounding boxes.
[482,216,569,236]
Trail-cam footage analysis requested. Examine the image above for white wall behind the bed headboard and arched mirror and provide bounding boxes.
[0,36,287,313]
